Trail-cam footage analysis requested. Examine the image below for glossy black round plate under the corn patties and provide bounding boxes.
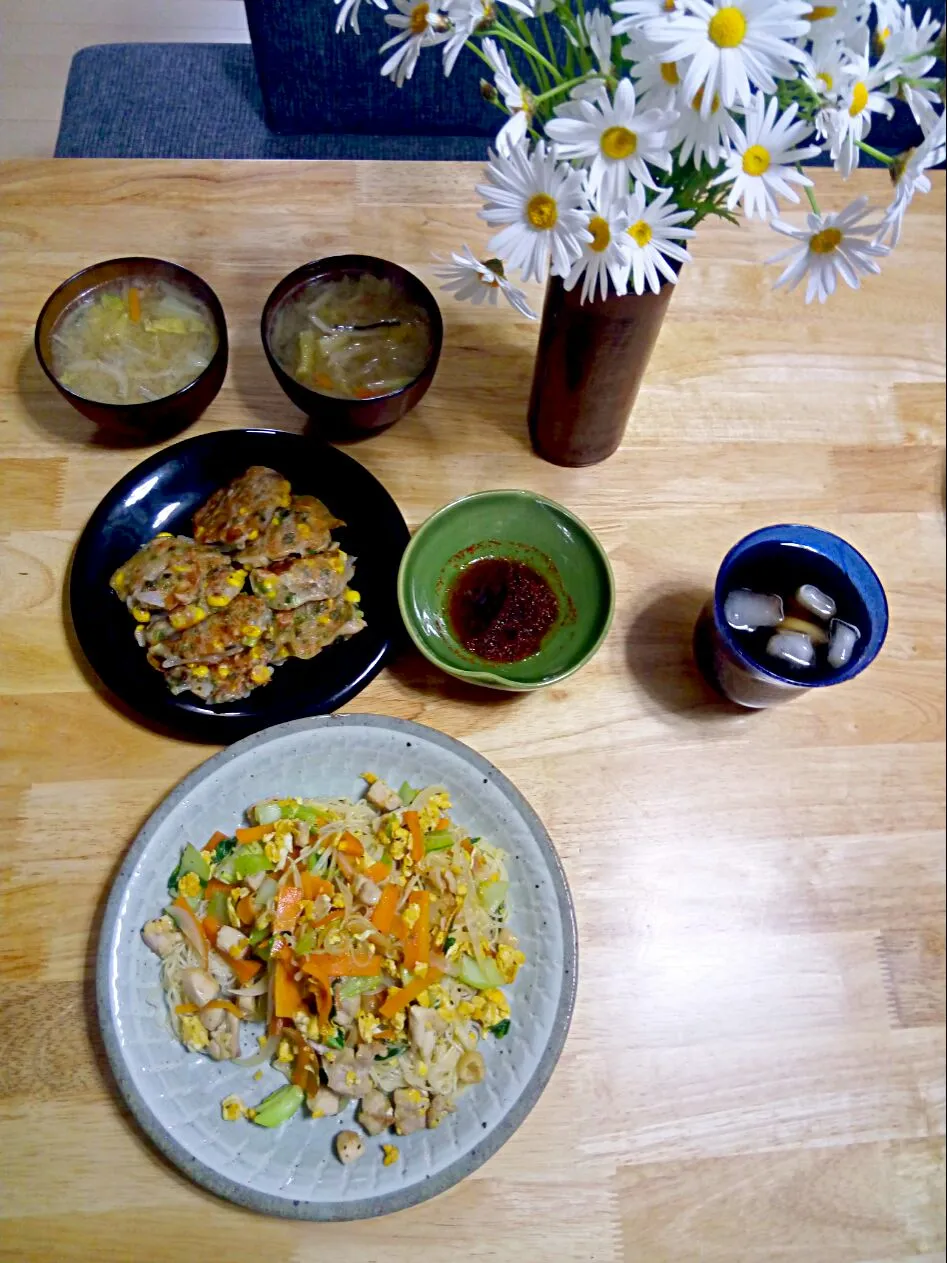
[69,429,409,744]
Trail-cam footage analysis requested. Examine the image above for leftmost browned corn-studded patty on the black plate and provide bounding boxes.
[110,536,246,629]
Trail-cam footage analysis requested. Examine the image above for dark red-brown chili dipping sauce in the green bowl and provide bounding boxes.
[447,557,559,662]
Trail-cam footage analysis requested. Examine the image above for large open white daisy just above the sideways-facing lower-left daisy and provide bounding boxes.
[477,140,590,280]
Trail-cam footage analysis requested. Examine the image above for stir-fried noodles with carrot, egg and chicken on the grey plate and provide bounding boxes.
[143,773,524,1161]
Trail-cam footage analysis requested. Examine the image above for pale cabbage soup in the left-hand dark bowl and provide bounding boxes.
[52,278,217,404]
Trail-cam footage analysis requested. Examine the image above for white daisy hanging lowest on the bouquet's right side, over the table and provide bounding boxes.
[766,196,890,303]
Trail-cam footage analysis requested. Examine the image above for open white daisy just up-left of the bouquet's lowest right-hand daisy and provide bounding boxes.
[711,92,819,220]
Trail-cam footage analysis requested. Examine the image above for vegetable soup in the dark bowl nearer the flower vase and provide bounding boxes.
[270,273,431,399]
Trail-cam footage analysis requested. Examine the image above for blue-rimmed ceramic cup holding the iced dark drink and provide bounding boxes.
[694,525,888,709]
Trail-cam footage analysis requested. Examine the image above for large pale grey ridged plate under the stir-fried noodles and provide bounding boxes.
[96,715,577,1220]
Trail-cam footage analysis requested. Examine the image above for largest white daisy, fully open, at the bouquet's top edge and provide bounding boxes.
[648,0,812,114]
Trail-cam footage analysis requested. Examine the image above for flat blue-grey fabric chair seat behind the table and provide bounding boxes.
[56,44,487,160]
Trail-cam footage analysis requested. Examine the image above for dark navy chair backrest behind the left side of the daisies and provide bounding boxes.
[245,0,503,138]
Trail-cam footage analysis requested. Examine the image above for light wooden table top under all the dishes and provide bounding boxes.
[0,162,944,1263]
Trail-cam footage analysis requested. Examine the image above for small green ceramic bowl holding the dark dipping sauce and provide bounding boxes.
[398,491,615,692]
